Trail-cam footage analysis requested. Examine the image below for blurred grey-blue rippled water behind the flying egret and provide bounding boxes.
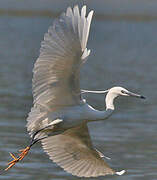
[0,0,157,180]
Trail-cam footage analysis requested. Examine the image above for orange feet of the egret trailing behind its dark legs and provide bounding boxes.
[5,146,30,171]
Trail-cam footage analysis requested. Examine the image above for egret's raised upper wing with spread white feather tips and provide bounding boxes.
[32,6,93,110]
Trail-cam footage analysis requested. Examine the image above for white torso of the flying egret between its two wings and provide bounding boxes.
[43,103,112,129]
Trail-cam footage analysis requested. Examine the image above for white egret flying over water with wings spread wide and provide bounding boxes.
[6,6,144,177]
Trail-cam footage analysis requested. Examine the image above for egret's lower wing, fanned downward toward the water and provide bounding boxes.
[42,125,116,177]
